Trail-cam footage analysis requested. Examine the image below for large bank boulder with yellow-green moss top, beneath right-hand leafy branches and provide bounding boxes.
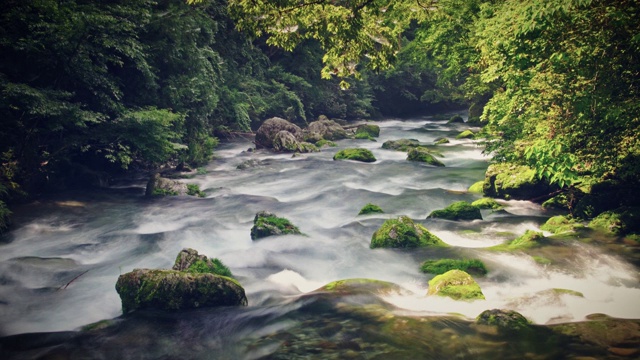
[482,163,553,200]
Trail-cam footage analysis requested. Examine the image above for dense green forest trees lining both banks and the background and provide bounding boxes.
[0,0,640,233]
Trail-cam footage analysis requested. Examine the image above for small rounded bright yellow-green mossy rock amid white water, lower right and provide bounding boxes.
[427,270,485,301]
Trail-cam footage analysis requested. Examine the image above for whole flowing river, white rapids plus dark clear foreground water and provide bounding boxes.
[0,117,640,359]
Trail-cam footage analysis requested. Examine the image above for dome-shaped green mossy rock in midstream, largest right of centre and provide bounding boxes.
[370,216,447,249]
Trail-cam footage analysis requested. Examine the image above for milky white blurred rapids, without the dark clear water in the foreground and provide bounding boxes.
[0,119,640,335]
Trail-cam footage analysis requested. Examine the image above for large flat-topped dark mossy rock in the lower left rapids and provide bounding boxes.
[116,269,247,314]
